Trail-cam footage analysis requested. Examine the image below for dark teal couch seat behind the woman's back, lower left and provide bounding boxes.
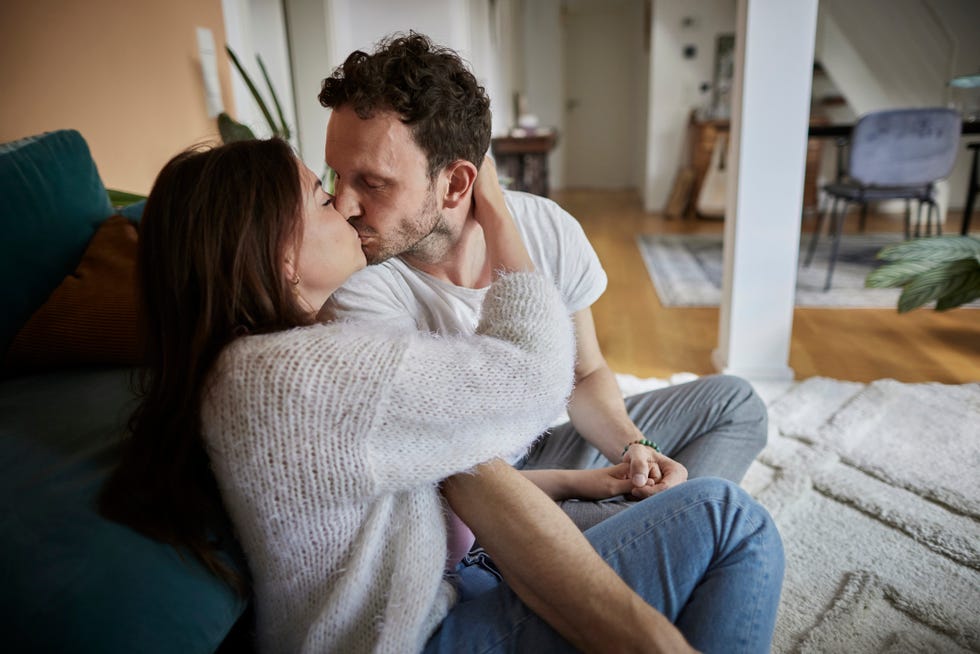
[0,368,245,654]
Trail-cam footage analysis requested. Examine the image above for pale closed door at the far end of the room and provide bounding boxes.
[562,0,645,189]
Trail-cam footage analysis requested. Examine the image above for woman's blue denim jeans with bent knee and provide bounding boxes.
[425,478,783,654]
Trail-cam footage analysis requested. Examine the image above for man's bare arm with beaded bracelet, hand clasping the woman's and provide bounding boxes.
[568,307,687,497]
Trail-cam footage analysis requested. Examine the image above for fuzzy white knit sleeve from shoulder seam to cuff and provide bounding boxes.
[369,273,575,492]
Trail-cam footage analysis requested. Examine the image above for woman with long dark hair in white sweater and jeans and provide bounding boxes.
[106,140,782,652]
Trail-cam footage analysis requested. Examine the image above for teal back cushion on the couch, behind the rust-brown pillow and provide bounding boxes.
[0,130,112,352]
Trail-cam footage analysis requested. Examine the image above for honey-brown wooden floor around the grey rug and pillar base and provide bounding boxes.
[552,190,980,384]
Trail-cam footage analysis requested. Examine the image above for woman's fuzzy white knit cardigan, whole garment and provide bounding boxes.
[202,273,575,653]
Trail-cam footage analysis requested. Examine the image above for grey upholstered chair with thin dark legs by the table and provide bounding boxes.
[804,107,961,291]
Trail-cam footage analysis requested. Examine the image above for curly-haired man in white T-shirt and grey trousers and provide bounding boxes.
[319,33,767,528]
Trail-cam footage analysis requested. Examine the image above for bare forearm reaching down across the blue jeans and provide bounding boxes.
[443,460,693,652]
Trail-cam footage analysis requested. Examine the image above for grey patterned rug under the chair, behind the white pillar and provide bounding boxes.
[637,233,980,308]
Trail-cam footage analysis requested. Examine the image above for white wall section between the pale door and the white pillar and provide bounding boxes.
[643,0,735,211]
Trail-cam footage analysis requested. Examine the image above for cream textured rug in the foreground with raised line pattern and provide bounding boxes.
[618,375,980,654]
